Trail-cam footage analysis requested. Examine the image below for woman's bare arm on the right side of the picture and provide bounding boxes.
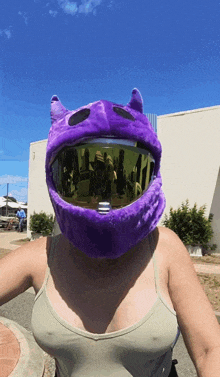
[160,228,220,377]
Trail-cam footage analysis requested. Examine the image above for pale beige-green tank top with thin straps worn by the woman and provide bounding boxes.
[32,237,178,377]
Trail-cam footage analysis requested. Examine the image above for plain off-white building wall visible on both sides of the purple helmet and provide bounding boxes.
[28,106,220,253]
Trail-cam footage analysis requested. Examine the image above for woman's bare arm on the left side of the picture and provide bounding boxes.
[0,238,47,305]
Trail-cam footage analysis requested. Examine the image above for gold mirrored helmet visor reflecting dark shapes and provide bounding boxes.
[52,139,154,209]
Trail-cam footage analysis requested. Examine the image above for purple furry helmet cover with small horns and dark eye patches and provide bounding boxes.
[46,89,165,259]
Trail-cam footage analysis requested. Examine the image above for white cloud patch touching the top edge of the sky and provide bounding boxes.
[58,0,102,15]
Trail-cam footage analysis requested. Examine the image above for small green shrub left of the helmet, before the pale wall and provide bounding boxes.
[29,212,54,236]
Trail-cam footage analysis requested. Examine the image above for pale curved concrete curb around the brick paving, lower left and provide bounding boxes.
[0,317,44,377]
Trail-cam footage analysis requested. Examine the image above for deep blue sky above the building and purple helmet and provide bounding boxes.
[0,0,220,201]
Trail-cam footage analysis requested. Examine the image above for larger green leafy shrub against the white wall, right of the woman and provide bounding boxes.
[162,199,217,251]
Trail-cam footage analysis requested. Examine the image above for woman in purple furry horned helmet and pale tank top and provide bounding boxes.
[0,89,220,377]
